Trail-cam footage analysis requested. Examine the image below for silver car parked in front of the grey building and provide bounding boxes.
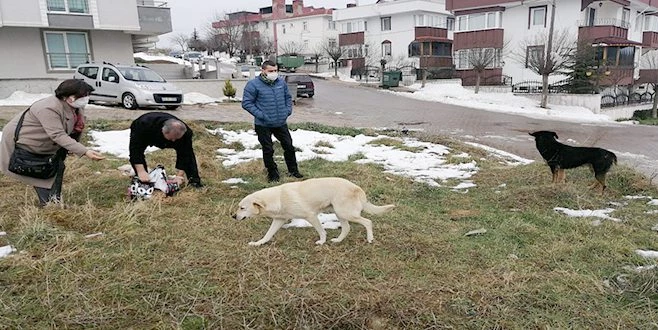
[73,63,183,110]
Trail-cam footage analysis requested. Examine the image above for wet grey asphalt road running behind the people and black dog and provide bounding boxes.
[0,79,658,177]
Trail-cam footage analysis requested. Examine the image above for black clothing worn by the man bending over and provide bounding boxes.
[129,112,199,182]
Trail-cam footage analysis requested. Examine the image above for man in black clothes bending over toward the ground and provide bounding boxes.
[129,112,203,188]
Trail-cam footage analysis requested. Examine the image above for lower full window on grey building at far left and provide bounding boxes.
[44,31,91,70]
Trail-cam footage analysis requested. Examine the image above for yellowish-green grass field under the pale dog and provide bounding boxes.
[0,122,658,329]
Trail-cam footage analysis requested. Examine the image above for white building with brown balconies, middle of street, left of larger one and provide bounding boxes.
[334,0,455,74]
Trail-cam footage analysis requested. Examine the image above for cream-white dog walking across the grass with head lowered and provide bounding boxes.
[233,178,395,246]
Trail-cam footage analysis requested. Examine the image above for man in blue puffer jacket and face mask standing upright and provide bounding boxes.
[242,61,304,182]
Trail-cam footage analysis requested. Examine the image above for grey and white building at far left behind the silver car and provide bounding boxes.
[0,0,172,79]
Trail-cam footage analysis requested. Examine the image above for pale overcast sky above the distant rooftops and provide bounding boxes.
[158,0,376,47]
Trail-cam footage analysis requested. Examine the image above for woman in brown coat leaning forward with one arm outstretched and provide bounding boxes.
[0,79,105,206]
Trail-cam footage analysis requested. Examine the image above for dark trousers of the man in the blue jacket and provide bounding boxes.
[255,125,299,173]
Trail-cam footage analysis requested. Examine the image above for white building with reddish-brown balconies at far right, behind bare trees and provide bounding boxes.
[446,0,658,86]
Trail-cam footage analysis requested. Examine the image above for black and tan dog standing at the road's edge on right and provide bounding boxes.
[529,131,617,192]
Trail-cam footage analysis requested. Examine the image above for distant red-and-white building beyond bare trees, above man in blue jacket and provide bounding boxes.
[212,0,338,56]
